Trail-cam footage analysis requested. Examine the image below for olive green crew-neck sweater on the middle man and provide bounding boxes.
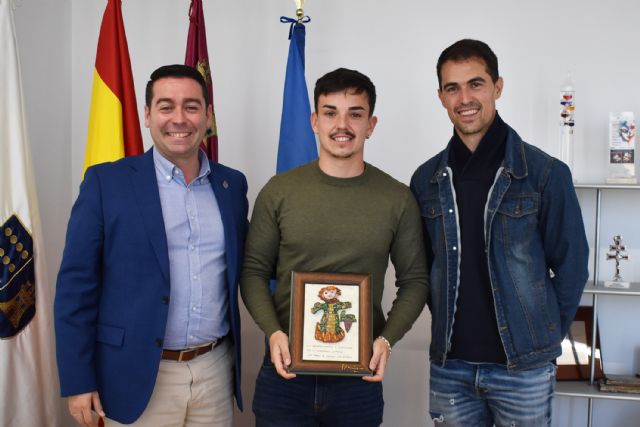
[240,161,429,345]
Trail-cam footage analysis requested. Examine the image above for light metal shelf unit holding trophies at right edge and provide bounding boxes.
[555,184,640,427]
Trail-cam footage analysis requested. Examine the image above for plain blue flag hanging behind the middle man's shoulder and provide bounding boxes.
[276,17,318,173]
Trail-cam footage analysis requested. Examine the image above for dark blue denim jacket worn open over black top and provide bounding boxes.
[411,128,589,370]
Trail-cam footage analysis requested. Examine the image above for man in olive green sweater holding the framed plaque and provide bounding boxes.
[240,68,428,427]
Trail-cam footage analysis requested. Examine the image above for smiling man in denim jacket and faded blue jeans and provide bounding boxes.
[411,39,589,426]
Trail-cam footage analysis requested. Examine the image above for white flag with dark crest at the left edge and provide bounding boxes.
[0,0,62,427]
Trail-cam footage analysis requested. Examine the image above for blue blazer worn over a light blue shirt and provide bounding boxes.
[54,149,248,424]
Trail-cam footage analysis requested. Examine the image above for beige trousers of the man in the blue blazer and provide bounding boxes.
[104,339,233,427]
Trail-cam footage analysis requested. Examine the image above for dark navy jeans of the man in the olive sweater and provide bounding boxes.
[253,358,384,427]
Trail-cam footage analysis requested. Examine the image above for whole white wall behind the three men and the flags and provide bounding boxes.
[16,0,640,426]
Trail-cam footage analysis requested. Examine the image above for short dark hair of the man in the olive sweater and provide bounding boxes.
[313,68,376,116]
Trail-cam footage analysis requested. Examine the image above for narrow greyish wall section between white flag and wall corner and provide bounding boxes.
[14,1,71,308]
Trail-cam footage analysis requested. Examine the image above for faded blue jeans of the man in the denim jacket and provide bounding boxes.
[429,360,556,427]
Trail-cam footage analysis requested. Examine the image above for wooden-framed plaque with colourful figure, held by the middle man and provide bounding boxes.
[289,271,373,376]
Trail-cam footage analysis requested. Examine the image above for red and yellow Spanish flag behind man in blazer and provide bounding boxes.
[83,0,143,173]
